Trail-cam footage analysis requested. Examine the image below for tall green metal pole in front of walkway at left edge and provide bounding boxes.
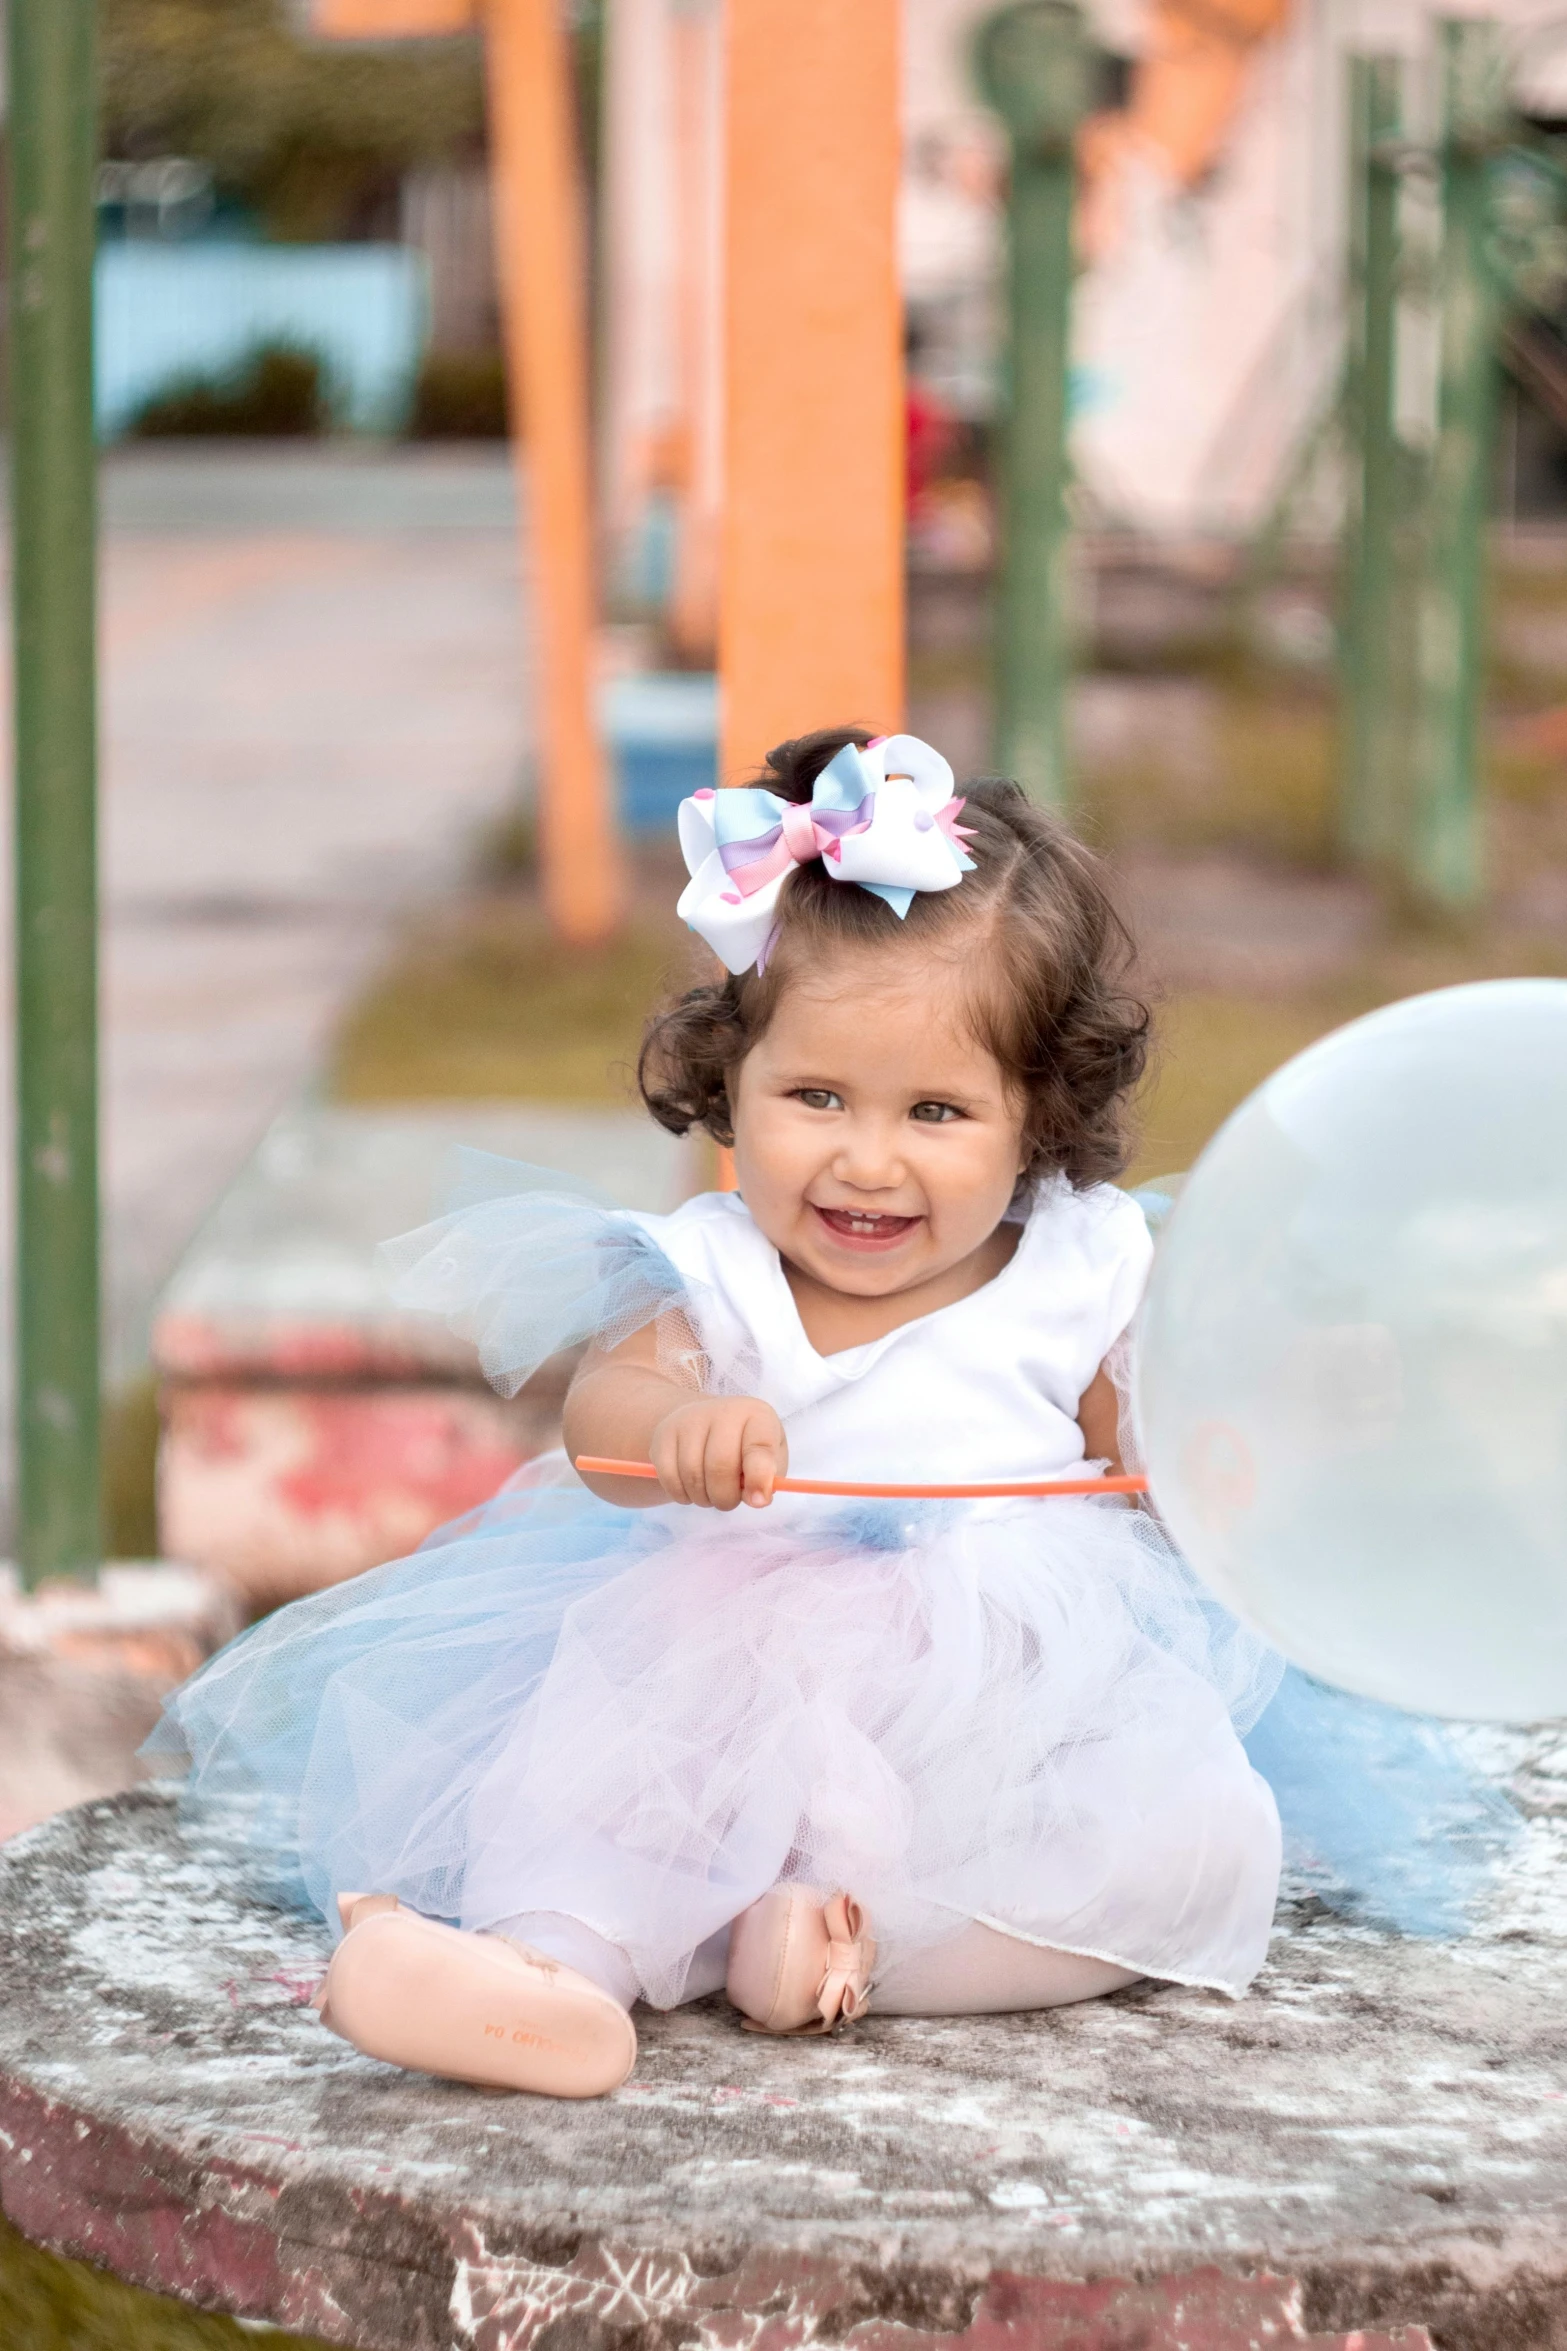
[9,0,101,1582]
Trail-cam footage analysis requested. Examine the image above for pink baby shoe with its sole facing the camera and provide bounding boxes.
[315,1895,637,2097]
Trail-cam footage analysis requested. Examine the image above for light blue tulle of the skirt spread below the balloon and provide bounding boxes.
[1245,1667,1522,1937]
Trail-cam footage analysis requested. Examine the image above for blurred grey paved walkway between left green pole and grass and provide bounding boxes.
[0,449,526,1514]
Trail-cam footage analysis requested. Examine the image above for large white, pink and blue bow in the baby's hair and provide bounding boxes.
[677,736,975,971]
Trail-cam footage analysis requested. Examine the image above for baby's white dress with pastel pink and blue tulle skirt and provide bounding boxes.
[164,1166,1280,2005]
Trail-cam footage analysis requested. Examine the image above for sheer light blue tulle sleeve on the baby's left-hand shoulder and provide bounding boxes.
[381,1150,691,1396]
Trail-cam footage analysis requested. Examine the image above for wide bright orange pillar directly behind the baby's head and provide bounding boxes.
[719,0,904,783]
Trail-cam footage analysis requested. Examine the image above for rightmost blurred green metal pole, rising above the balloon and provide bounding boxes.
[1407,19,1506,912]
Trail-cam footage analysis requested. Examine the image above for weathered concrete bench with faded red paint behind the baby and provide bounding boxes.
[153,1105,698,1608]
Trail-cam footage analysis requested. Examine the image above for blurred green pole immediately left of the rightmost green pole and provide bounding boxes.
[1339,56,1405,865]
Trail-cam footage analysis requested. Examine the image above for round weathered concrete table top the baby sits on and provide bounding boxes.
[0,1735,1567,2351]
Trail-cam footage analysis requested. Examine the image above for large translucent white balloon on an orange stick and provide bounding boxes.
[1137,980,1567,1721]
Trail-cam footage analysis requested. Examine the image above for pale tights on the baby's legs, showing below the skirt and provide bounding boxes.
[496,1911,1137,2017]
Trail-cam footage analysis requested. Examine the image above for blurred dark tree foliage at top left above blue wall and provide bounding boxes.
[101,0,484,240]
